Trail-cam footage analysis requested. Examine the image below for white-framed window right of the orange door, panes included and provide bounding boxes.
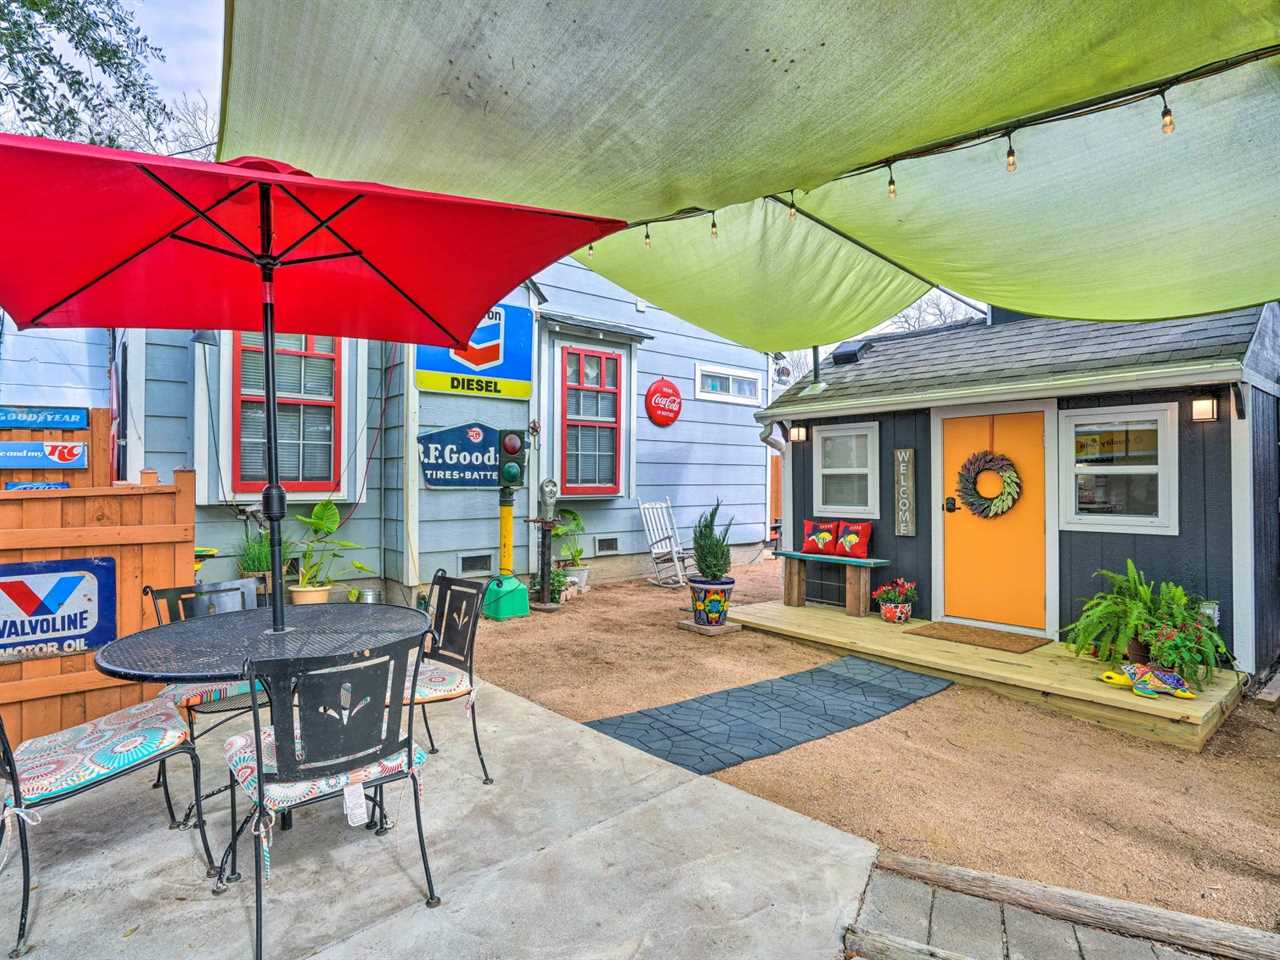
[1057,403,1178,536]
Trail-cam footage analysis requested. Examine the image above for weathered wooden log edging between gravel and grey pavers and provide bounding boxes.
[876,850,1280,960]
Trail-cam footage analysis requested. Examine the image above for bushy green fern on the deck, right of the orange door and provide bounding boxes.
[1062,561,1157,666]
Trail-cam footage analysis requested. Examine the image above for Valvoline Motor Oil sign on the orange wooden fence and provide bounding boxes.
[0,557,115,662]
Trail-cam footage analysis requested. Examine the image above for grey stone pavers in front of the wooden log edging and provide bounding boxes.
[856,869,1207,960]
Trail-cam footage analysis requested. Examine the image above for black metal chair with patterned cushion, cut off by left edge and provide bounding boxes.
[0,700,214,957]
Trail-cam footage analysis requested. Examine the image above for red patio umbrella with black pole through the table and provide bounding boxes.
[0,134,625,630]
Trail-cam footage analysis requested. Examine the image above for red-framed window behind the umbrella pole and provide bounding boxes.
[232,333,342,493]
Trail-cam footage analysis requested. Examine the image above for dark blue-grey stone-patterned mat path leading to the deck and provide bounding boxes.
[586,657,951,773]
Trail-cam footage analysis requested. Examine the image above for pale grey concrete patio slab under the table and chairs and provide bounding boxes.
[0,686,874,960]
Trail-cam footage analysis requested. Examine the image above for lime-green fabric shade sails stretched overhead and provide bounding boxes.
[220,0,1280,349]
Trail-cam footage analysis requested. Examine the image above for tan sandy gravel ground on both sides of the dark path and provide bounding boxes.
[476,561,1280,931]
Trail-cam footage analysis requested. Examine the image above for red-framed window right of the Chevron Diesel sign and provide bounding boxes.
[559,347,623,497]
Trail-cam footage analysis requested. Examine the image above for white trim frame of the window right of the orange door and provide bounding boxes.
[1057,402,1179,536]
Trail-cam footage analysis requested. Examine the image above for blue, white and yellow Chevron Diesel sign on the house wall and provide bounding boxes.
[416,303,534,399]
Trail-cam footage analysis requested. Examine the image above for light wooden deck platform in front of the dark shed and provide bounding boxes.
[730,600,1240,751]
